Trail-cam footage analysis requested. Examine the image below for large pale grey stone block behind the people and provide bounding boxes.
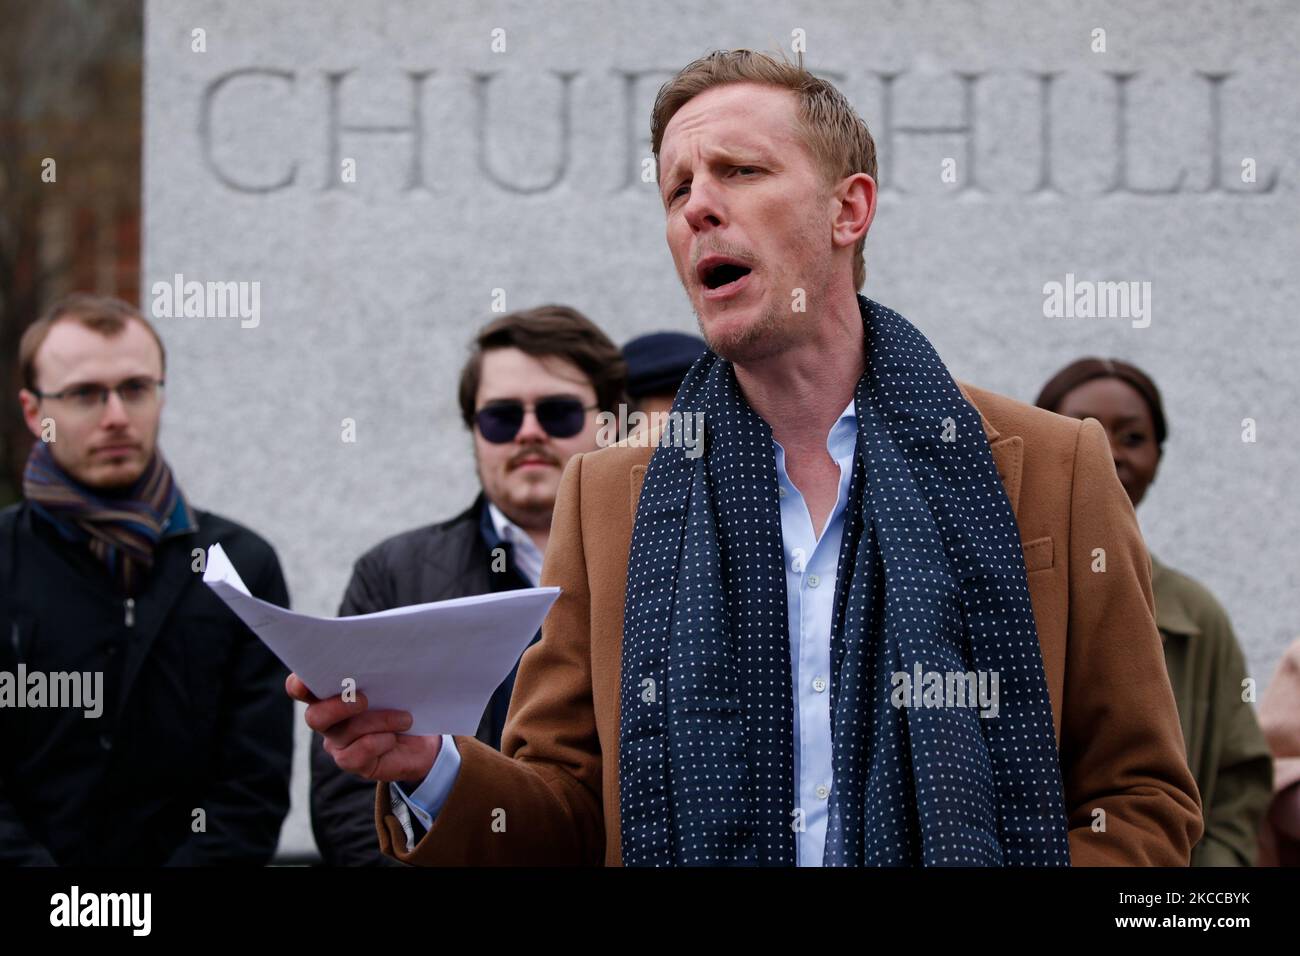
[143,0,1300,851]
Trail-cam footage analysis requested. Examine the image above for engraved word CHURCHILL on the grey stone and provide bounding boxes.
[196,66,1279,202]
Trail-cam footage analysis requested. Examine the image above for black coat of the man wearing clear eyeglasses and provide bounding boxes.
[0,503,294,866]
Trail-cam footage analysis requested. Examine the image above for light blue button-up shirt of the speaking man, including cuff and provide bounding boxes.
[391,399,858,866]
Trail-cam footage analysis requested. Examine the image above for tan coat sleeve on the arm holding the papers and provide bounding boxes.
[374,454,605,866]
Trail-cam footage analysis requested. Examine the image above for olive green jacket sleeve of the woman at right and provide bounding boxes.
[1192,604,1273,866]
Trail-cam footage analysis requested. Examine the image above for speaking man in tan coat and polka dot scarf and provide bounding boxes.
[287,51,1201,866]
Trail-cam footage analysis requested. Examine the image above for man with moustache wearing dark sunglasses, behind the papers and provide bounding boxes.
[312,306,625,866]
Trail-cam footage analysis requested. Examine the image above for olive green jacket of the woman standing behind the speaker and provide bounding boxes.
[1151,555,1273,866]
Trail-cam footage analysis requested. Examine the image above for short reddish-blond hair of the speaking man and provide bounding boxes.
[650,49,876,289]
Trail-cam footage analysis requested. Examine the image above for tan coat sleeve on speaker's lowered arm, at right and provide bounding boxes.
[1061,419,1203,866]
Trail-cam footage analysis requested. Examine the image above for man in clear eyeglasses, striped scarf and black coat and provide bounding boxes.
[0,294,294,866]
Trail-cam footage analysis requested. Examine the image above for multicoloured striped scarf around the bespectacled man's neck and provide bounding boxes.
[22,441,198,594]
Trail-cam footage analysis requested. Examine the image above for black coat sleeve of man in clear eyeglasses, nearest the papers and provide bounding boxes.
[168,549,294,866]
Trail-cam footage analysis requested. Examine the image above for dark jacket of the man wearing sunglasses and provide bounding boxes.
[311,494,537,866]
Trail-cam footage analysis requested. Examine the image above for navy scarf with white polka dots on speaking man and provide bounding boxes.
[619,297,1070,866]
